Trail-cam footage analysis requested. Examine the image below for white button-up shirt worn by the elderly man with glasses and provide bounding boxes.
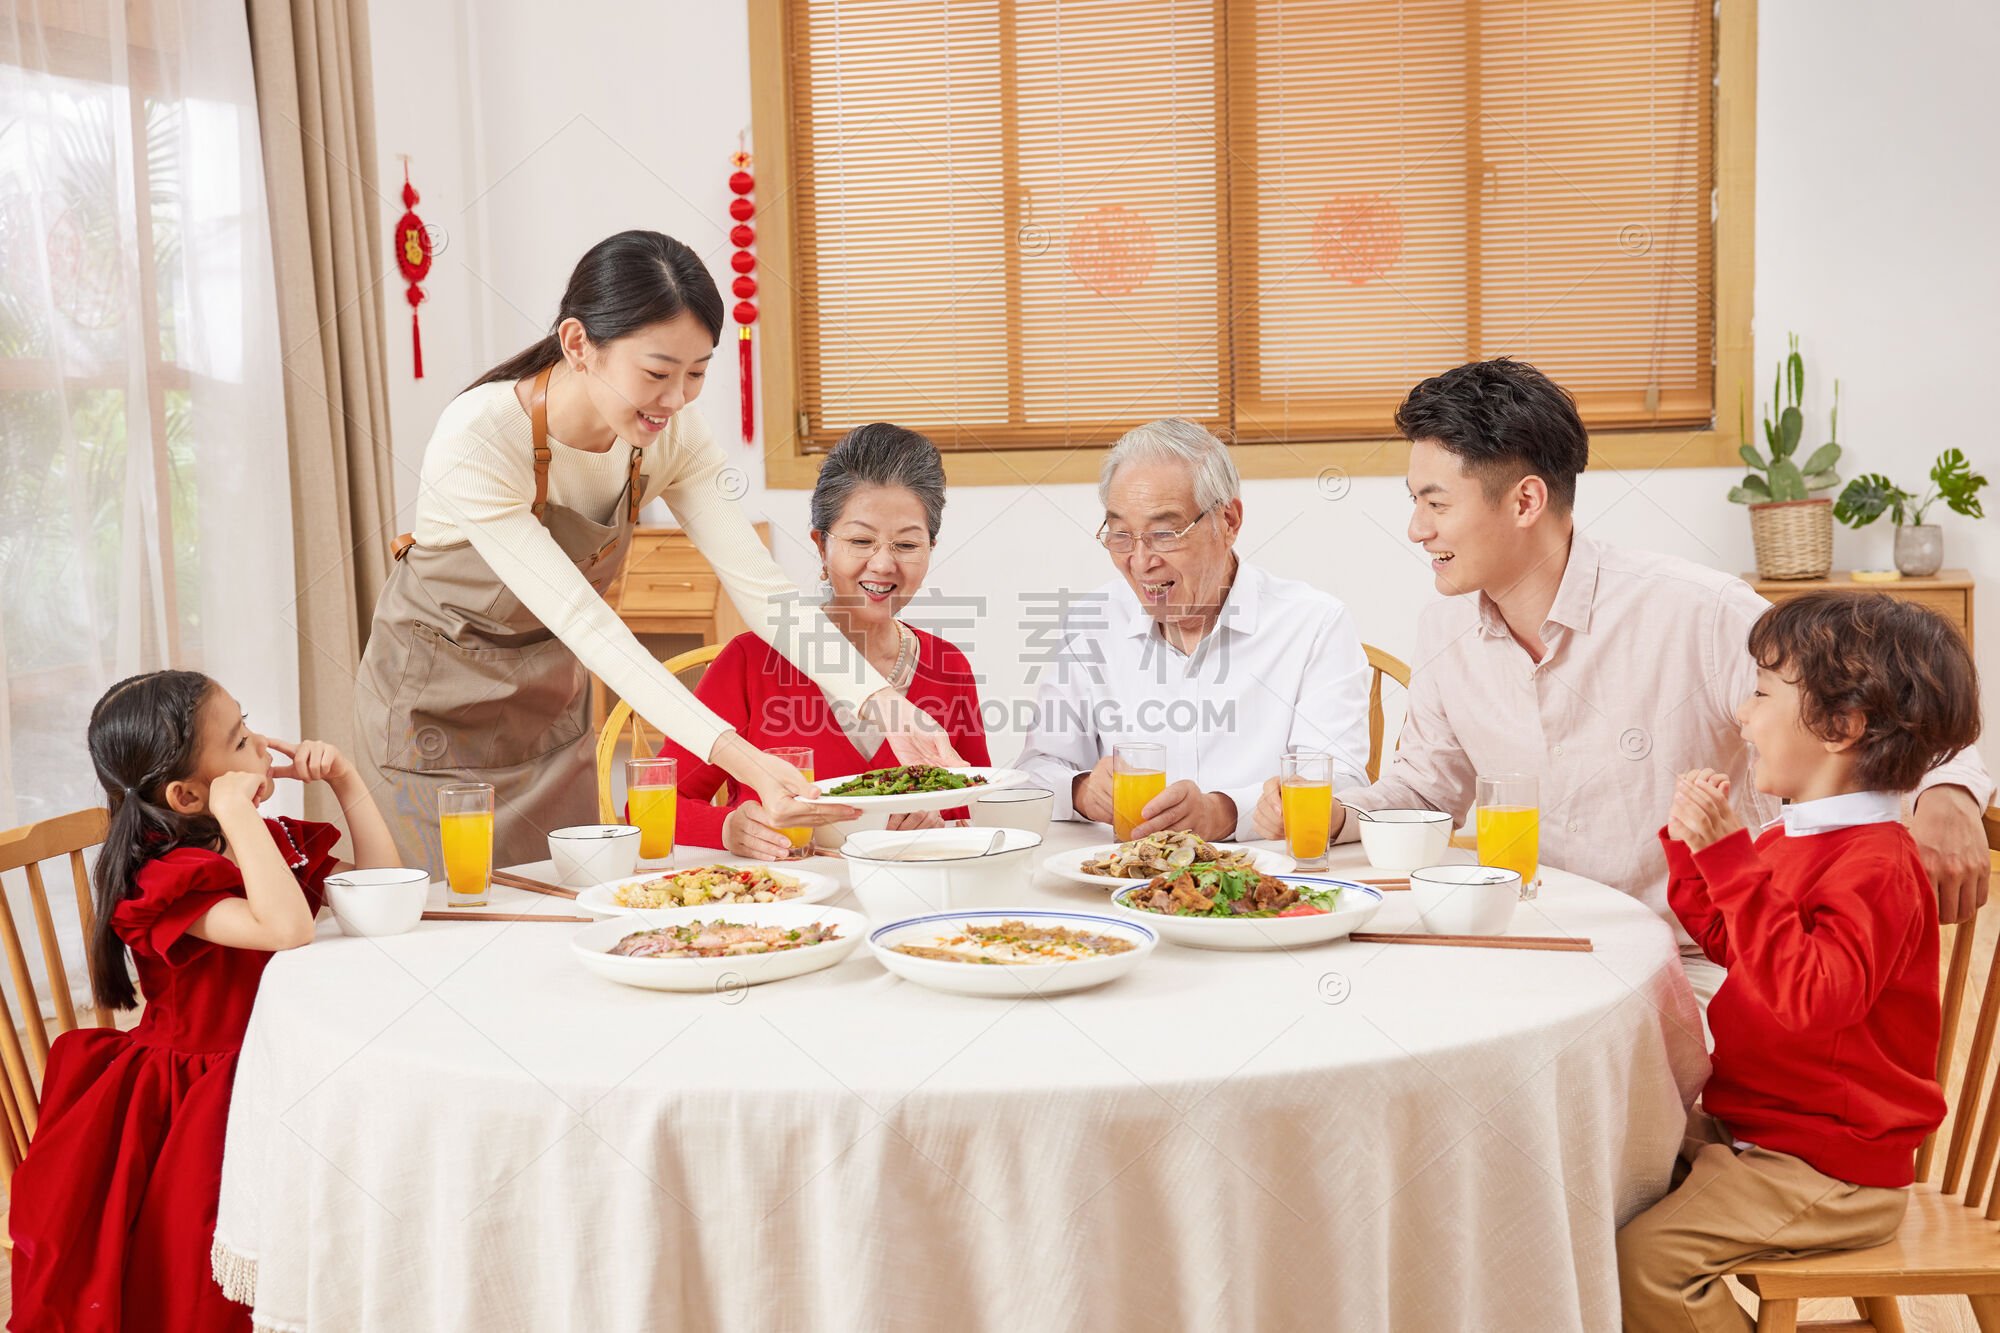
[1016,560,1368,839]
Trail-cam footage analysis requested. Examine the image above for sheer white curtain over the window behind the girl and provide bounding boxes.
[0,0,298,1008]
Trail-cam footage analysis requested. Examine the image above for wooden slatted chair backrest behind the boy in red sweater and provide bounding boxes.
[1916,809,2000,1221]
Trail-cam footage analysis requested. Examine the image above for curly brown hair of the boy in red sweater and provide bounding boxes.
[1750,592,1980,791]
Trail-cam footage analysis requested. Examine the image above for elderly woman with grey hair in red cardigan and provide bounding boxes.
[660,422,990,861]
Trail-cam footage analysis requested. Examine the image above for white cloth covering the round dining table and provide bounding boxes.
[216,825,1706,1333]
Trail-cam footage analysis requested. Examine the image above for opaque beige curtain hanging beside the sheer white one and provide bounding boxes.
[246,0,396,819]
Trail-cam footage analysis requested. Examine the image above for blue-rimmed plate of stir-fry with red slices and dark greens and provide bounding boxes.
[1112,865,1382,949]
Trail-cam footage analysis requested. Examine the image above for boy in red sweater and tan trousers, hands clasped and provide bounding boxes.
[1618,592,1980,1333]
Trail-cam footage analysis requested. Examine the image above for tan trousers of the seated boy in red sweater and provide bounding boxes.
[1618,1107,1910,1333]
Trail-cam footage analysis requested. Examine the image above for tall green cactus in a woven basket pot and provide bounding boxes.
[1730,334,1840,578]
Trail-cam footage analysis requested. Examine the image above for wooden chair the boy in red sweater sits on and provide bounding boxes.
[1736,792,2000,1333]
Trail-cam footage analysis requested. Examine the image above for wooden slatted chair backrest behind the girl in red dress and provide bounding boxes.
[0,809,112,1183]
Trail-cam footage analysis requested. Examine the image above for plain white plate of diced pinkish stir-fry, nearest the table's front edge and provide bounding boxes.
[570,903,868,991]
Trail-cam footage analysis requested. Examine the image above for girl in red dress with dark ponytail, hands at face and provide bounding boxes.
[8,671,396,1333]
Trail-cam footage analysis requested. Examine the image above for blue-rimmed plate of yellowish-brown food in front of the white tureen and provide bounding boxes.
[868,909,1158,999]
